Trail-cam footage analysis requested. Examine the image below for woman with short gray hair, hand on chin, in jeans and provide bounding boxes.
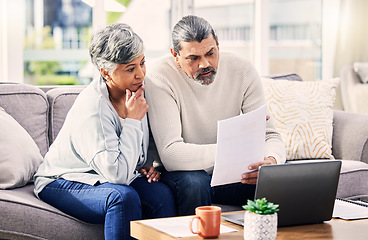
[35,24,176,239]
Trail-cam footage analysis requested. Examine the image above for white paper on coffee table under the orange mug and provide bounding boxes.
[141,216,238,238]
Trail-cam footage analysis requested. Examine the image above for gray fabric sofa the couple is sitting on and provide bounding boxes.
[0,83,368,239]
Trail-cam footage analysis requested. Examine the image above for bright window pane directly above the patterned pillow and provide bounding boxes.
[269,0,322,81]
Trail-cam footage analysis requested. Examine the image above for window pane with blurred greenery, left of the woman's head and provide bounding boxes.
[23,0,92,85]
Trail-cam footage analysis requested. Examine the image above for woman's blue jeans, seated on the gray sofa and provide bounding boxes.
[39,177,176,239]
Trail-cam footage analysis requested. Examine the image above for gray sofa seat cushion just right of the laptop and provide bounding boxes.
[336,160,368,200]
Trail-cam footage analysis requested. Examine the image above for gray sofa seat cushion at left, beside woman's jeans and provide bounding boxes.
[0,184,104,239]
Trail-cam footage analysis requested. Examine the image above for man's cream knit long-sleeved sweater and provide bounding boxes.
[146,52,285,174]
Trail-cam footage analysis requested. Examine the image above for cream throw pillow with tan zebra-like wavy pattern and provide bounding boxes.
[262,78,340,160]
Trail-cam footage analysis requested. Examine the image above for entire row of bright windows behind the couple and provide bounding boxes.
[0,0,324,85]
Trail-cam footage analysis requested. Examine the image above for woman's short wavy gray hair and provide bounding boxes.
[89,23,143,74]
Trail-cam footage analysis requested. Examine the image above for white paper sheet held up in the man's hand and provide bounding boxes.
[211,105,267,186]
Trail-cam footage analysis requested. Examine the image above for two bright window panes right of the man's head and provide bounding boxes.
[193,0,322,80]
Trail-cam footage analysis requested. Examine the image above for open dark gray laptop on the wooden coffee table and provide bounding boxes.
[222,160,341,227]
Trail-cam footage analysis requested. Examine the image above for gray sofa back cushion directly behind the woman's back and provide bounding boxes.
[46,86,86,144]
